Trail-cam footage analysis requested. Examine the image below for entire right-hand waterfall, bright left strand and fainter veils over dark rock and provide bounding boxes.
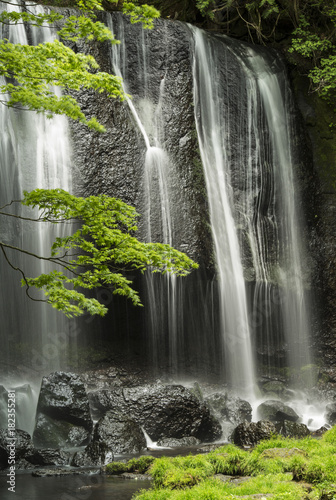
[191,28,310,394]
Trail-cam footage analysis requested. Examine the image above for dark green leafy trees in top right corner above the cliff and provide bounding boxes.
[196,0,336,106]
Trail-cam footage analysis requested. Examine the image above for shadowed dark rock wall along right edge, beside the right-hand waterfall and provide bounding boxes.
[294,74,336,372]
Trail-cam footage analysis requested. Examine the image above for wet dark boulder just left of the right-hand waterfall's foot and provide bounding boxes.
[205,393,252,425]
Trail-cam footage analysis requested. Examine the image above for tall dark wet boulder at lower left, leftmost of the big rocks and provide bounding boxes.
[33,372,93,448]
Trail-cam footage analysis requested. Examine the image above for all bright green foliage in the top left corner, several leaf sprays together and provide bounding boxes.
[0,0,159,128]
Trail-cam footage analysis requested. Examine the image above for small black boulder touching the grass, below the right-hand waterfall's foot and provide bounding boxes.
[232,420,277,446]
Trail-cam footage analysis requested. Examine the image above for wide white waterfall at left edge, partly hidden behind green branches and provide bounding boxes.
[0,1,71,432]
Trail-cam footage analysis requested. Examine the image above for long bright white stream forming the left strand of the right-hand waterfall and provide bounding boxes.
[193,29,255,396]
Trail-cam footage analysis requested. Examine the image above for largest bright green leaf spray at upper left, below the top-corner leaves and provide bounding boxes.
[0,40,124,132]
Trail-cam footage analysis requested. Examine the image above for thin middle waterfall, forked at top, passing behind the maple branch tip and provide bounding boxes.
[107,16,180,372]
